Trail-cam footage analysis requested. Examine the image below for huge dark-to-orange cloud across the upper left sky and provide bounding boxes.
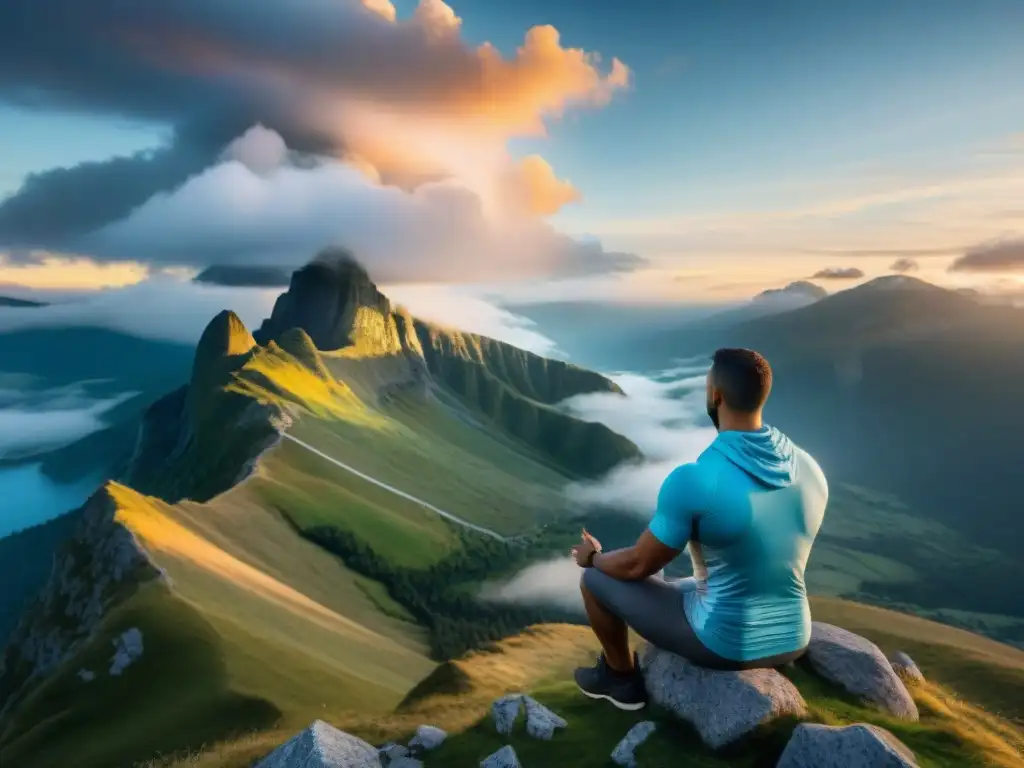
[0,0,631,244]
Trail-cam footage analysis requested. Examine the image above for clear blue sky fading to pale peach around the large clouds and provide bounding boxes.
[0,0,1024,301]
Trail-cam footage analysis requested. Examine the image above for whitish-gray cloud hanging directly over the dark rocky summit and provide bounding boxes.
[79,128,642,283]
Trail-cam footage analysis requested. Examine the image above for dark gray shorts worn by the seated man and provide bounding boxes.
[583,568,804,671]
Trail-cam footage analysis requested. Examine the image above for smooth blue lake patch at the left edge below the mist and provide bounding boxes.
[0,464,100,538]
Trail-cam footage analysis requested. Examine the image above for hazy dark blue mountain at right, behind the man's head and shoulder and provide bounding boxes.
[646,275,1024,565]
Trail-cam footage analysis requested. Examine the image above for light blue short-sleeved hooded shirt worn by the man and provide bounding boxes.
[649,426,828,662]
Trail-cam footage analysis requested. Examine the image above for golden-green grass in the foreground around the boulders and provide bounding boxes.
[159,614,1024,768]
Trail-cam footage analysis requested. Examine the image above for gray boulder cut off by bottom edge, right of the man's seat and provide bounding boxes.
[776,723,918,768]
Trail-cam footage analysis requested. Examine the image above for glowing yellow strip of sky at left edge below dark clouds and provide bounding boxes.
[0,254,148,291]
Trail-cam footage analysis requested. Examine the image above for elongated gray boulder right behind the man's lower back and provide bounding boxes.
[807,622,919,721]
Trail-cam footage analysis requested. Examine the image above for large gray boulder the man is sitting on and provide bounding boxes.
[640,644,807,749]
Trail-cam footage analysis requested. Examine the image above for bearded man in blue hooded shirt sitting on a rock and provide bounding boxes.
[572,349,828,710]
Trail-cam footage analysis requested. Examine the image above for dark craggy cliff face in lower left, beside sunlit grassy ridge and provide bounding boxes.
[0,487,163,717]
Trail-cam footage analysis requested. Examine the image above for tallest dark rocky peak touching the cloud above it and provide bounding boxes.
[255,248,391,350]
